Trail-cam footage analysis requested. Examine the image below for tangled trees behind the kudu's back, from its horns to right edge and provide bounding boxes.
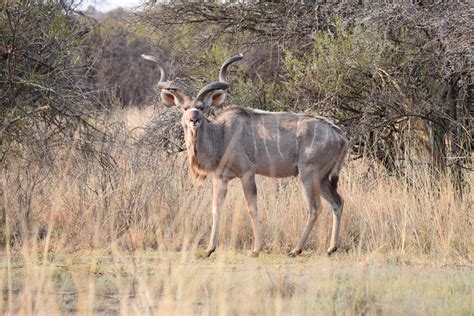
[138,1,473,190]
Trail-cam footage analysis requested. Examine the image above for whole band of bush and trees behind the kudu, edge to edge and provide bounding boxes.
[0,1,473,186]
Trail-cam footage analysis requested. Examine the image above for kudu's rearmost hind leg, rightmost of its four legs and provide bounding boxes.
[321,179,344,255]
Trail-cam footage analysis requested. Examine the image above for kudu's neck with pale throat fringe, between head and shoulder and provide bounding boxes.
[184,120,223,180]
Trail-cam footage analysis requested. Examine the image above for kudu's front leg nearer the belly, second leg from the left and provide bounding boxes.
[241,175,262,257]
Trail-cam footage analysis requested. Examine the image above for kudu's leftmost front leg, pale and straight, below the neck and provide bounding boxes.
[206,177,228,257]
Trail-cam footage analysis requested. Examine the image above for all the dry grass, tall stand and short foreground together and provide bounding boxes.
[0,107,474,314]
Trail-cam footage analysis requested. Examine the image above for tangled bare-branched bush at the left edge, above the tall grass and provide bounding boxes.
[0,1,100,163]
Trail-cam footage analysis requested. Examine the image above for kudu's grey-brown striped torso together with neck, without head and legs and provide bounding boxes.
[184,107,346,179]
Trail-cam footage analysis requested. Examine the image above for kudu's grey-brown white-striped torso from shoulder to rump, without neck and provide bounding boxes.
[215,107,347,178]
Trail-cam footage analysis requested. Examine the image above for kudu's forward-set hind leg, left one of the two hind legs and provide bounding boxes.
[288,173,321,257]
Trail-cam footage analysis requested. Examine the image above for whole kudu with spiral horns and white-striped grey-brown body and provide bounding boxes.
[142,55,347,256]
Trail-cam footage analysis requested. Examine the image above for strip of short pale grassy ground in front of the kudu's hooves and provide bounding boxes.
[1,250,474,315]
